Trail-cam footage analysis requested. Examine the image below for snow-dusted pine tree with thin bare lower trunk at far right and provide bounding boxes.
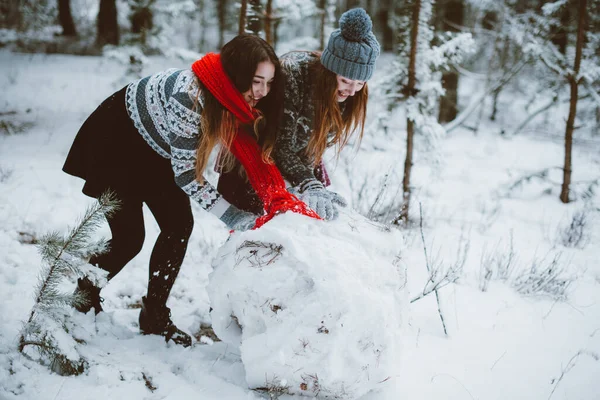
[512,0,600,203]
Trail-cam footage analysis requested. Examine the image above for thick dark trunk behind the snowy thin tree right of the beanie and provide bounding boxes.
[437,0,465,123]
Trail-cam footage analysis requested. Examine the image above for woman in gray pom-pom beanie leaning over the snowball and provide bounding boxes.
[220,8,380,220]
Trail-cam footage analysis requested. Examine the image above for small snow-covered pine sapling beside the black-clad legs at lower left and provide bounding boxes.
[19,193,118,375]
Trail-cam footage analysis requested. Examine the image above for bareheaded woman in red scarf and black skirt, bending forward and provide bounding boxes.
[63,35,316,346]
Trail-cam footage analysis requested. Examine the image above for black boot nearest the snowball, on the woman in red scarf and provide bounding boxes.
[140,297,192,347]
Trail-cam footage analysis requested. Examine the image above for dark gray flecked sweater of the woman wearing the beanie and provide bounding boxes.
[273,51,344,186]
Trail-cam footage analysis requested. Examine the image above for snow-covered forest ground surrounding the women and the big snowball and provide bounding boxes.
[0,51,600,400]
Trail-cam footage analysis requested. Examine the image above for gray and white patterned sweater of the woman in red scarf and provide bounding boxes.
[126,69,229,217]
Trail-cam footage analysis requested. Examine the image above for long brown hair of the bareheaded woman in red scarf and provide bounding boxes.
[196,34,283,182]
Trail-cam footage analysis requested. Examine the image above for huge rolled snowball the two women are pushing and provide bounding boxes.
[208,212,406,399]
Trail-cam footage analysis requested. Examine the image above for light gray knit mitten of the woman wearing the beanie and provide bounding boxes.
[292,179,347,220]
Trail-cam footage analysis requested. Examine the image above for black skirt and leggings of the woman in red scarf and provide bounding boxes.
[63,89,194,308]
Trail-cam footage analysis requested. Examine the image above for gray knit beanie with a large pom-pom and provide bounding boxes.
[321,8,379,81]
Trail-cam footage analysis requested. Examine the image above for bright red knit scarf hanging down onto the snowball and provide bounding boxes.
[192,53,320,229]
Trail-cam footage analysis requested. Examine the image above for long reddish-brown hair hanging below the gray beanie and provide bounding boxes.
[306,52,369,165]
